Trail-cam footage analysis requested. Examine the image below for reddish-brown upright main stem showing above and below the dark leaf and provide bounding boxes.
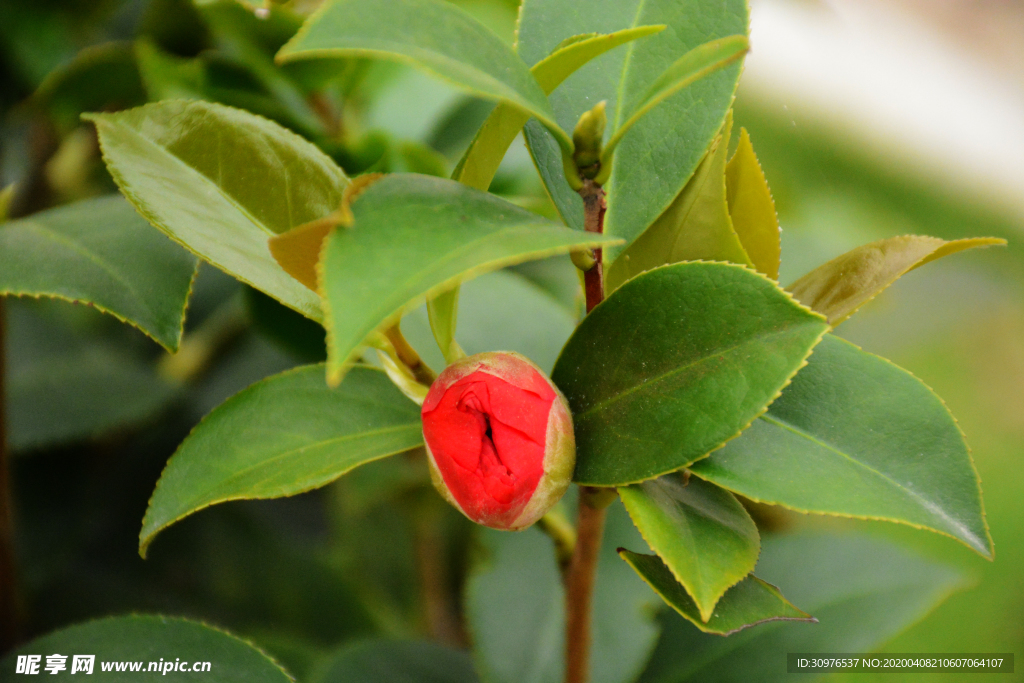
[565,180,607,683]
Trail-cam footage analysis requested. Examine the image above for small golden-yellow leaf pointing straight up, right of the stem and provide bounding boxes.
[724,128,781,280]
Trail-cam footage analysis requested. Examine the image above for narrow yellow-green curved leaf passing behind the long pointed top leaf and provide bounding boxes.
[452,26,665,190]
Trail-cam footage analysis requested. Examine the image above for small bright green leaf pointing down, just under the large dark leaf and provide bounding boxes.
[618,474,761,623]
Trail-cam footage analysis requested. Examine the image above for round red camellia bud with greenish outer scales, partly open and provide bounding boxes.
[423,351,575,529]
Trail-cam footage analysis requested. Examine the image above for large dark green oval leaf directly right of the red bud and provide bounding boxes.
[552,262,827,486]
